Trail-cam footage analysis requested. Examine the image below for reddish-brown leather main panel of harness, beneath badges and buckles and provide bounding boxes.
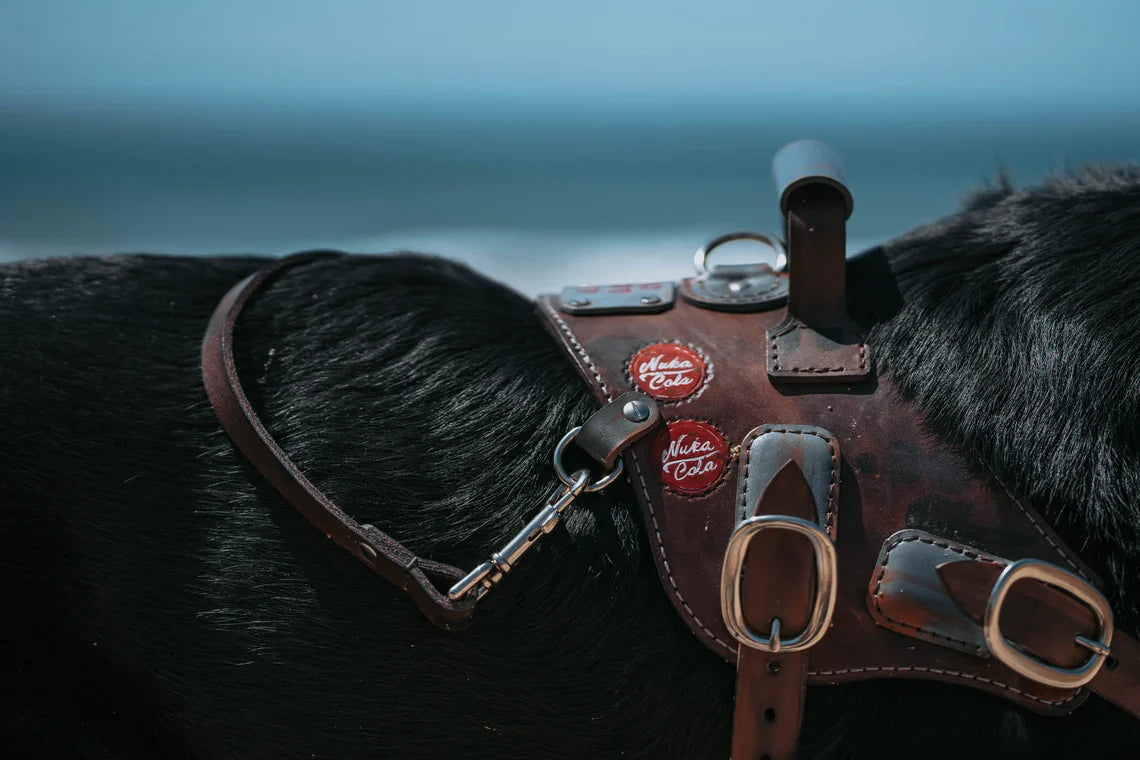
[539,287,1096,714]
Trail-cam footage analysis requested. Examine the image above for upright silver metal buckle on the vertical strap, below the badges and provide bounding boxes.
[720,515,838,652]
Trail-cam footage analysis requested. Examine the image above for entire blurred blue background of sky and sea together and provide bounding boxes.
[0,0,1140,293]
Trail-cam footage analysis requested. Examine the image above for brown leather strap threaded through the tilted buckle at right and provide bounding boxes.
[938,559,1140,718]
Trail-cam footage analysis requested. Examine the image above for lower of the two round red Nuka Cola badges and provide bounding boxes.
[652,419,728,496]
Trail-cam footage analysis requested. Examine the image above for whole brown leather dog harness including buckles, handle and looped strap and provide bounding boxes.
[202,144,1140,760]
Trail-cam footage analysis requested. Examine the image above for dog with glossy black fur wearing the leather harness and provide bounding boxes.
[0,171,1140,760]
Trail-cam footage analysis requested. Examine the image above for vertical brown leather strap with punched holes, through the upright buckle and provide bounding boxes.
[732,460,816,760]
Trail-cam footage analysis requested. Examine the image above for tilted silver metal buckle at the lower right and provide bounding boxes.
[982,559,1113,688]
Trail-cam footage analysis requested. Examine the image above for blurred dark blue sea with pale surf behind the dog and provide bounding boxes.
[0,103,1140,293]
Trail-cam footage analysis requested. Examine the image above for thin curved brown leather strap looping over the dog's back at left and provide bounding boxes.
[202,252,475,630]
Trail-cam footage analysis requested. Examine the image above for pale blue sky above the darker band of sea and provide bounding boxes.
[0,0,1140,107]
